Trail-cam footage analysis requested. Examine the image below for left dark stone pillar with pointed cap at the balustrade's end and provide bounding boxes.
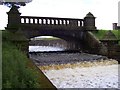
[6,6,21,30]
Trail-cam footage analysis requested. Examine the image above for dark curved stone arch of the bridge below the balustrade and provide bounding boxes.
[19,28,88,50]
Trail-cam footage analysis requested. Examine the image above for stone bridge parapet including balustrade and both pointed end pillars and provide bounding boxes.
[6,6,96,32]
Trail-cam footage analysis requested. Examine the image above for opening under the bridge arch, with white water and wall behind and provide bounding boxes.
[29,36,83,52]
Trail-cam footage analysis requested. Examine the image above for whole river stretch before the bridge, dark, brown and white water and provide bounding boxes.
[29,48,119,88]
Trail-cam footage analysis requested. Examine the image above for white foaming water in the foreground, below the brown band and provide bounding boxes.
[43,65,118,88]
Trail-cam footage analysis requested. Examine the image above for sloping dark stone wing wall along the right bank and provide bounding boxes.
[84,32,120,62]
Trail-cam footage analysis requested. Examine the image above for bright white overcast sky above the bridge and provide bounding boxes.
[0,0,119,30]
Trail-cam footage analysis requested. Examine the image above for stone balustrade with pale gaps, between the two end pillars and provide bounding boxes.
[21,16,84,27]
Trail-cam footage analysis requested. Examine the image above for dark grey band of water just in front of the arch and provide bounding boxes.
[30,53,107,65]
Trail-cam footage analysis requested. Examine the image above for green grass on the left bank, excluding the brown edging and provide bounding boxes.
[2,41,40,88]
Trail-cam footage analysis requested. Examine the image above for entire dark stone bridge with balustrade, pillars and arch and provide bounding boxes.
[6,6,104,54]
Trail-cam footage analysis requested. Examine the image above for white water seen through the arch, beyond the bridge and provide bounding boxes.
[29,46,64,52]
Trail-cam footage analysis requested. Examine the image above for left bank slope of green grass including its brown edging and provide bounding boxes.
[2,32,53,88]
